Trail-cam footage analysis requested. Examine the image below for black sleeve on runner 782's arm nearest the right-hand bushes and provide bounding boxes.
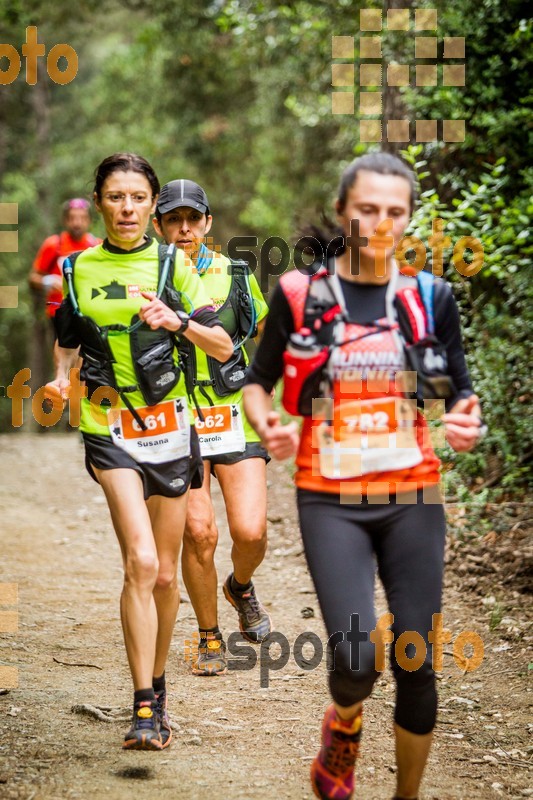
[433,280,474,409]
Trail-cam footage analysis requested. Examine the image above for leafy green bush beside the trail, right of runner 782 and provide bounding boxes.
[404,145,533,496]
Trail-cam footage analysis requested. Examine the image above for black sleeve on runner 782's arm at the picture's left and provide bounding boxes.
[246,283,294,392]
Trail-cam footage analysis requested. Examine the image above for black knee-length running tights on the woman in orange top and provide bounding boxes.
[297,487,445,734]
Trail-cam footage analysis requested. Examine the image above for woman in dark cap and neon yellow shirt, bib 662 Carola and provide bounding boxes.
[154,179,270,675]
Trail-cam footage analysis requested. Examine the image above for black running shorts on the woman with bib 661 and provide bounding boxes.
[83,427,204,500]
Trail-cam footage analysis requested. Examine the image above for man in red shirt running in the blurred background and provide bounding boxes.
[28,198,101,400]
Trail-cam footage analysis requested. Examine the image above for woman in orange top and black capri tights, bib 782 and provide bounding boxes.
[245,153,482,800]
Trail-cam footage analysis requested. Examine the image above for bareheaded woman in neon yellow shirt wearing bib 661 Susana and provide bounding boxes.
[49,153,232,750]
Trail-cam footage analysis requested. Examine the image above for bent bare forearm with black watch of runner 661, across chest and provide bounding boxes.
[139,292,233,362]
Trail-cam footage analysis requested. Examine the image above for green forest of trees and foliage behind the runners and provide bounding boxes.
[0,0,533,511]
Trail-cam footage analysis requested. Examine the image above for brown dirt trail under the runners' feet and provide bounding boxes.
[0,433,533,800]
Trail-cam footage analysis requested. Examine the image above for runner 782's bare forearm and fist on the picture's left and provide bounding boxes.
[244,383,300,461]
